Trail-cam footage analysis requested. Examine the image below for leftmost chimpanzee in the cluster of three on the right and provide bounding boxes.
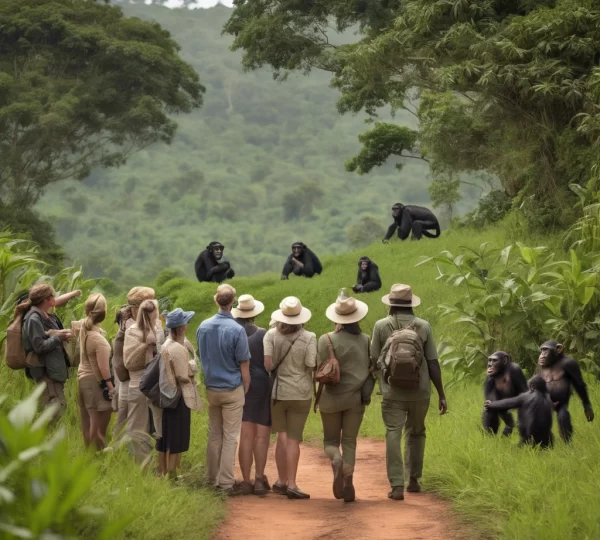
[482,351,527,436]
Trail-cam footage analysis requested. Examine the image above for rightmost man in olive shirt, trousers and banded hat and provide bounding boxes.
[371,284,448,500]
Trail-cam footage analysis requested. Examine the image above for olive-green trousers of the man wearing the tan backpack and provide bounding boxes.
[381,399,429,489]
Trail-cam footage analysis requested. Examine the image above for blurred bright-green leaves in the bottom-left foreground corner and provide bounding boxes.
[0,386,129,540]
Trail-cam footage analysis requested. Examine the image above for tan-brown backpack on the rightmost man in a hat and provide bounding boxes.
[383,320,425,390]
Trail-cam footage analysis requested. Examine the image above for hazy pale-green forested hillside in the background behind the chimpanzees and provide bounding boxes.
[37,4,479,286]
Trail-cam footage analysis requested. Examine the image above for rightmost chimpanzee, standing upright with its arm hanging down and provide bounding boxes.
[537,340,594,442]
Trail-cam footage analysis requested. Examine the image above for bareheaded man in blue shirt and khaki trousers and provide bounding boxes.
[196,285,250,495]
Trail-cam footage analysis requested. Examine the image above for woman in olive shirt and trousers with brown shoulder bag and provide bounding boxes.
[317,289,373,502]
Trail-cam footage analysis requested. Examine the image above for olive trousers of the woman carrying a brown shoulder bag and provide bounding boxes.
[321,405,365,475]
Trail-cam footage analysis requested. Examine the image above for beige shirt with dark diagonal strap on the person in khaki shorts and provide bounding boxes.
[263,328,317,401]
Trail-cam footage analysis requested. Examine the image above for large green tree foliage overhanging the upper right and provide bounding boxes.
[224,0,600,226]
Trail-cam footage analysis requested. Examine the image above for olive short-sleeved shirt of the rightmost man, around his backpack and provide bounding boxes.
[371,313,437,401]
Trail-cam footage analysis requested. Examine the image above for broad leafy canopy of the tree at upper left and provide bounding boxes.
[0,0,204,227]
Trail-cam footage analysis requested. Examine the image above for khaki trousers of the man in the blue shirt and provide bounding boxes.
[206,386,246,489]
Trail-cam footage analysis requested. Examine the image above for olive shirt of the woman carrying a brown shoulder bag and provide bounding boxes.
[318,331,369,413]
